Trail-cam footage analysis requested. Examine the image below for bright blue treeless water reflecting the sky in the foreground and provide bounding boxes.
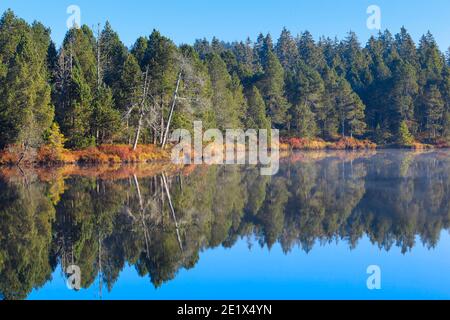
[29,231,450,300]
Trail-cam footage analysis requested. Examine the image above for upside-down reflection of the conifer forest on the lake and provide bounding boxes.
[0,152,450,299]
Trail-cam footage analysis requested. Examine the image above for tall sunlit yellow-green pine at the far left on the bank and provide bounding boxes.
[0,10,54,151]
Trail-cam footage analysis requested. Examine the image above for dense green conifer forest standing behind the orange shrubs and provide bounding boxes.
[0,11,450,154]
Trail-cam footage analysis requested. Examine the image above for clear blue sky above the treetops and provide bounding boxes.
[0,0,450,51]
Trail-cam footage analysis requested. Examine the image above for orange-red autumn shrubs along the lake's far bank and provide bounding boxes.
[0,138,450,168]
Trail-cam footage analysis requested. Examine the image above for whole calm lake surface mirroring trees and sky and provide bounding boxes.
[0,150,450,299]
